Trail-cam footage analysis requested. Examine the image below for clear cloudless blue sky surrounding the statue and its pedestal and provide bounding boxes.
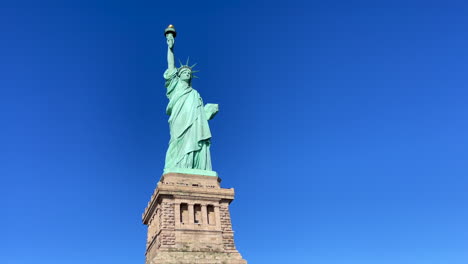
[0,0,468,264]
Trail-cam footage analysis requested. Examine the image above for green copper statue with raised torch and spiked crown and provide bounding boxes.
[164,25,218,174]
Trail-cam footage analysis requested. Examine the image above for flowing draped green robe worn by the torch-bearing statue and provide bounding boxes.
[164,68,212,170]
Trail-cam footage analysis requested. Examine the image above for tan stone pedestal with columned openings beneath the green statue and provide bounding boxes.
[142,173,247,264]
